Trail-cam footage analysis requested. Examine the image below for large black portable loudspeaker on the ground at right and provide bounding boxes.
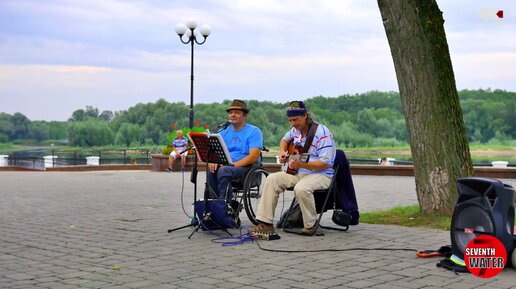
[450,178,516,259]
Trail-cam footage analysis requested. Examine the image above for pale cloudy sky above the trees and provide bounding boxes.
[0,0,516,120]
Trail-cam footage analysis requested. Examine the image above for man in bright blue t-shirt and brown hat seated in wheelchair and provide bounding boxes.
[208,99,263,200]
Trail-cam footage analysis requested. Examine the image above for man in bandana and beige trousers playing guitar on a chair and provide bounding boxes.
[250,101,336,235]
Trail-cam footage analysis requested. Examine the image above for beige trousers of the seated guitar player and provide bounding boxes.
[256,172,331,228]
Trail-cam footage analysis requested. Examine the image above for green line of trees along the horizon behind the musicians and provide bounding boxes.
[0,90,516,148]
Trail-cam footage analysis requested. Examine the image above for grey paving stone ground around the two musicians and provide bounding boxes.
[0,171,516,289]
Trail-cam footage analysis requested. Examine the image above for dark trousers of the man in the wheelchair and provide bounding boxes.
[208,166,250,201]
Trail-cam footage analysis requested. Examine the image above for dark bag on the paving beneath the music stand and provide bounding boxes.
[194,199,240,230]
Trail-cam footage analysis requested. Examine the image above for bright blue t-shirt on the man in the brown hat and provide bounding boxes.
[220,123,263,162]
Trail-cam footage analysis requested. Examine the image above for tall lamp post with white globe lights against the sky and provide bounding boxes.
[176,19,211,129]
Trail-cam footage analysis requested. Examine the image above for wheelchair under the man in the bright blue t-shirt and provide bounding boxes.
[230,147,269,225]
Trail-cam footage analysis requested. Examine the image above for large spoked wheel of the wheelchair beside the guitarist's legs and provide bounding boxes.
[243,168,269,225]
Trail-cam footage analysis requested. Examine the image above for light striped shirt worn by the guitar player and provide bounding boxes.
[283,124,336,178]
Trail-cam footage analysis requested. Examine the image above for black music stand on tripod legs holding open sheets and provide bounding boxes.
[188,132,232,239]
